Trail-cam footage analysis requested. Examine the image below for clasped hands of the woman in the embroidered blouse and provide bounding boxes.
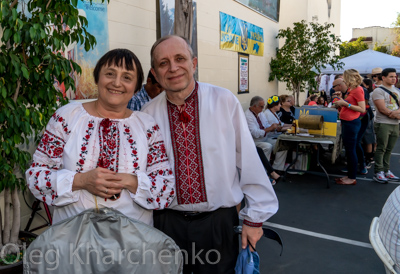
[72,167,138,198]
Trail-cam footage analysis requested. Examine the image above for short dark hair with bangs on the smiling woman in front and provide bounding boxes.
[93,49,144,92]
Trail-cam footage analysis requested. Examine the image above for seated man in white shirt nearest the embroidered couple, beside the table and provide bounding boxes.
[244,96,280,160]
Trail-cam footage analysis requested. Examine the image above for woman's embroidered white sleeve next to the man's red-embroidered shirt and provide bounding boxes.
[131,122,175,209]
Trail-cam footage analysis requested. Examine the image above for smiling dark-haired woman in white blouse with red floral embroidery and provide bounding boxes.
[26,49,175,225]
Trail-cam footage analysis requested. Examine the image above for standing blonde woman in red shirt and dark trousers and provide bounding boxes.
[335,69,365,185]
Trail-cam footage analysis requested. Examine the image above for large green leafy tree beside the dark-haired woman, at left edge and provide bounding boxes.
[0,0,104,252]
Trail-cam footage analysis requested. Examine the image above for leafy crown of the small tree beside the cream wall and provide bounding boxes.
[268,20,342,104]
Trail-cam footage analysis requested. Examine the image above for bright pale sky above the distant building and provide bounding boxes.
[340,0,400,41]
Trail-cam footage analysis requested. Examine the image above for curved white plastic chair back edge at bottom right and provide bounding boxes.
[369,217,397,274]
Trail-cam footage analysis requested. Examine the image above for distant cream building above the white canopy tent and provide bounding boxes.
[352,27,396,51]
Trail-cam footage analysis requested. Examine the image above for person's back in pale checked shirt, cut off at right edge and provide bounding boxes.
[378,187,400,273]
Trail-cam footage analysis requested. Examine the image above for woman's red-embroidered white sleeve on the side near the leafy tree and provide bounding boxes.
[26,112,77,205]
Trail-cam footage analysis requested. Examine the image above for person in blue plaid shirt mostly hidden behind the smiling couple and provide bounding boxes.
[128,71,163,111]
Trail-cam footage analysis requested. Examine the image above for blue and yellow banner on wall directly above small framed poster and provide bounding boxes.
[219,12,264,56]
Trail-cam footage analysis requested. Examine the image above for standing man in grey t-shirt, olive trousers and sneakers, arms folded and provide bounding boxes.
[372,68,400,184]
